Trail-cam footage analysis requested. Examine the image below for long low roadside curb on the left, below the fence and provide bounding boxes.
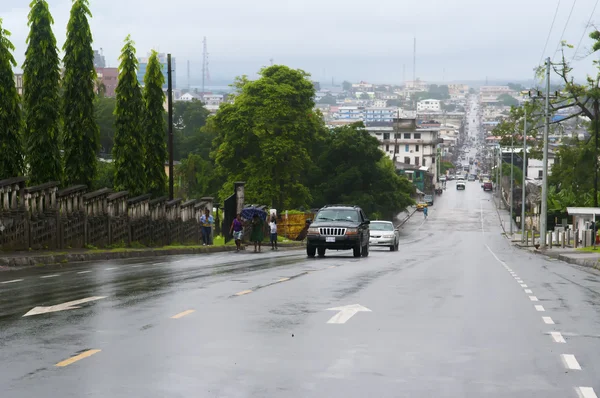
[0,243,304,268]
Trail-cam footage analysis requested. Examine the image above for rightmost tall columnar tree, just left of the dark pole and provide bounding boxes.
[143,51,167,195]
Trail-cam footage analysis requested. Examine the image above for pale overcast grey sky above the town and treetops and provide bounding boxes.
[0,0,600,85]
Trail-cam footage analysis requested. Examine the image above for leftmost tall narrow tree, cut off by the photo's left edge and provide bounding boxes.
[0,18,24,180]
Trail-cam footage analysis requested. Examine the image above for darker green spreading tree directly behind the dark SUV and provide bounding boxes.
[312,123,414,219]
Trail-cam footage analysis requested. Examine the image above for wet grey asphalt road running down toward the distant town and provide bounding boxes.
[0,112,600,398]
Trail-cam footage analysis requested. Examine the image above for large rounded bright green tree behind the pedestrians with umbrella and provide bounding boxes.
[212,65,324,209]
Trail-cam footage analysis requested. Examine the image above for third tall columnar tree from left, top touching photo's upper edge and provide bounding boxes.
[63,0,100,187]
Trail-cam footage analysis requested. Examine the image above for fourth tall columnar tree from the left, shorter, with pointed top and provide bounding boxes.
[113,36,146,195]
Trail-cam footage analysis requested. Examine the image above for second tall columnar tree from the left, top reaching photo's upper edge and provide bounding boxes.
[23,0,62,184]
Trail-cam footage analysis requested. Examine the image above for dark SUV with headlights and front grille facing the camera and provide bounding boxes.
[306,205,370,257]
